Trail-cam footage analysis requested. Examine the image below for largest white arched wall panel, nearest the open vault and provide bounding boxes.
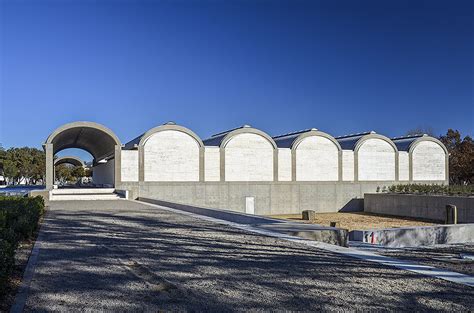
[143,130,199,181]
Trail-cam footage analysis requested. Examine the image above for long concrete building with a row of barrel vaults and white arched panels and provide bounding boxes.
[44,122,448,214]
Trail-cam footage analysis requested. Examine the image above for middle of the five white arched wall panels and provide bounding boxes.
[295,136,339,181]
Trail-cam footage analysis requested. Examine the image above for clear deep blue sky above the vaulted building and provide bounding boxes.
[0,0,474,161]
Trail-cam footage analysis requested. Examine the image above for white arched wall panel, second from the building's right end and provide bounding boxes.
[357,138,395,181]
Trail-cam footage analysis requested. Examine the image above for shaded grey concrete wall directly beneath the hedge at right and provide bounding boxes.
[364,193,474,223]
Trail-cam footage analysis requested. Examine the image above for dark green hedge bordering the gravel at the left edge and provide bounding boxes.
[0,196,44,295]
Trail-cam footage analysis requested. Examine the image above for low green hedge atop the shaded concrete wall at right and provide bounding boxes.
[386,184,474,196]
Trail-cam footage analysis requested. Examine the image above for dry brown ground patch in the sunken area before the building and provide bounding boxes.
[271,212,437,231]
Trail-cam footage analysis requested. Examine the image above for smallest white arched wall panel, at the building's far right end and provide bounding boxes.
[412,141,446,180]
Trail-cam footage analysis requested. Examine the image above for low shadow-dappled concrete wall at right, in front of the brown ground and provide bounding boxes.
[349,224,474,248]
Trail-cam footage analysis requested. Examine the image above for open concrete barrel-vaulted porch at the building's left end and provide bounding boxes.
[44,122,121,189]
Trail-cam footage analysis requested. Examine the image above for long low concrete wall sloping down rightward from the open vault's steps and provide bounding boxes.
[139,198,349,247]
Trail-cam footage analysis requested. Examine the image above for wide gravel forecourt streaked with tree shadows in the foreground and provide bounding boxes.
[19,201,474,311]
